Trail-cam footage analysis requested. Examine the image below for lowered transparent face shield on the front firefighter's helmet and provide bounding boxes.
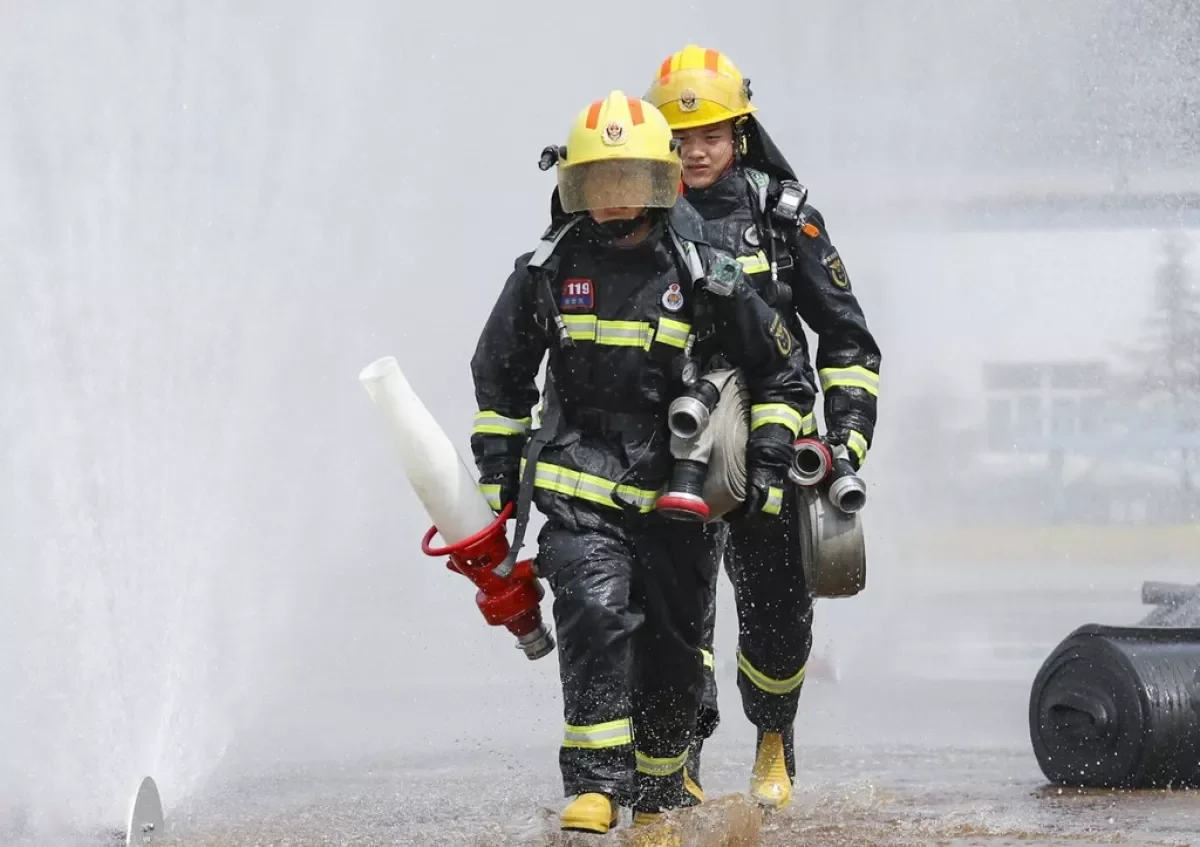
[558,154,682,214]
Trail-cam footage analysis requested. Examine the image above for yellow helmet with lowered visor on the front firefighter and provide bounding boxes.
[558,91,683,212]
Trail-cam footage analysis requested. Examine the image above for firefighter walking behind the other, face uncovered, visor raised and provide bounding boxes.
[646,44,880,809]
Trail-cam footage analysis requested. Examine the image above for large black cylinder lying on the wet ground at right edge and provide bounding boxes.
[1030,624,1200,788]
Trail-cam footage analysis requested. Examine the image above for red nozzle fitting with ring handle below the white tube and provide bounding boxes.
[421,503,554,660]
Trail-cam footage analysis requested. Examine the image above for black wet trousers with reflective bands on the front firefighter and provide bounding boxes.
[536,512,715,811]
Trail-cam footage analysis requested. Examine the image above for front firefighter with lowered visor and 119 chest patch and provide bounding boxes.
[470,91,812,834]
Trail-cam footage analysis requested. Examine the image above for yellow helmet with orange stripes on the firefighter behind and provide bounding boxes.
[646,44,757,130]
